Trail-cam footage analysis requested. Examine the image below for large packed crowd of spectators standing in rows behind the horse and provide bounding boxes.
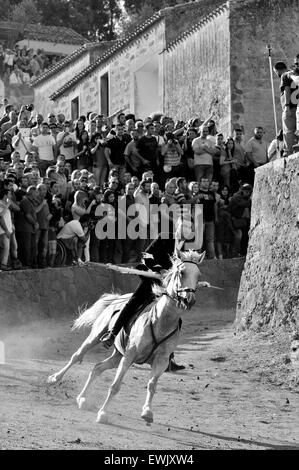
[0,92,296,271]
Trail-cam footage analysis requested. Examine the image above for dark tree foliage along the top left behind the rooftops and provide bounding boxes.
[0,0,196,41]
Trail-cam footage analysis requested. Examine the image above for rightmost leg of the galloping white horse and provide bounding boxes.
[141,354,169,423]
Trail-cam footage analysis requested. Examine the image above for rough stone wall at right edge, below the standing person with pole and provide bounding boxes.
[236,153,299,330]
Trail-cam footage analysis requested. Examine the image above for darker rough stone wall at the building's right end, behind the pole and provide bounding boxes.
[230,0,299,142]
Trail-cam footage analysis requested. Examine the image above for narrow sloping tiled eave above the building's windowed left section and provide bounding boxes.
[50,11,163,100]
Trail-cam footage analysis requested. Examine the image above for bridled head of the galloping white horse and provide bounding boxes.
[167,250,205,309]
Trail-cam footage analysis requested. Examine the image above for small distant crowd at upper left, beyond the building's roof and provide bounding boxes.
[0,44,61,85]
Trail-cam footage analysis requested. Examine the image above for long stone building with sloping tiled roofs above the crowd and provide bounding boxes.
[33,0,299,140]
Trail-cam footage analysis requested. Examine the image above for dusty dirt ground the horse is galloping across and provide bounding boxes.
[0,307,299,450]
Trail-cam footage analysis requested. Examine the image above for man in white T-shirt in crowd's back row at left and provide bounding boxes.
[33,122,56,176]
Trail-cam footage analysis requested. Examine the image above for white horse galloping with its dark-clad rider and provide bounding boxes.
[48,250,209,423]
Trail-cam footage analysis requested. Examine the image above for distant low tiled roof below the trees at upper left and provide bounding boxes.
[0,21,88,45]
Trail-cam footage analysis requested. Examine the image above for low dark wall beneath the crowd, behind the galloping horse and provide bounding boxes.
[0,259,243,326]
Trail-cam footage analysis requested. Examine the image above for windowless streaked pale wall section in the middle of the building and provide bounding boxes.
[163,9,231,134]
